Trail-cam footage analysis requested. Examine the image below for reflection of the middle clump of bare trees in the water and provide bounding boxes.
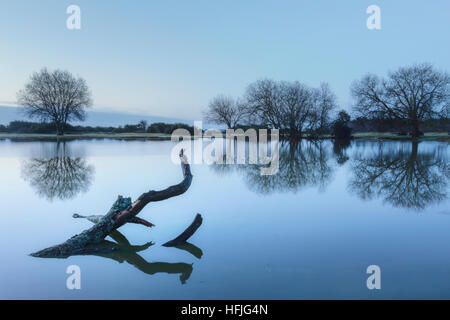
[212,140,333,194]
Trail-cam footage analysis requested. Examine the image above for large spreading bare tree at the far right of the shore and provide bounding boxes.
[351,64,450,137]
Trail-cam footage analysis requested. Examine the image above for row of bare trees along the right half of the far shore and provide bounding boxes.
[204,64,450,139]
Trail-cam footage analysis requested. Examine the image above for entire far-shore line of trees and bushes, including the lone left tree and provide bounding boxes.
[12,64,450,139]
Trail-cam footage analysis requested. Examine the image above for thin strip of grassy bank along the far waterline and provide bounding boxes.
[0,132,450,142]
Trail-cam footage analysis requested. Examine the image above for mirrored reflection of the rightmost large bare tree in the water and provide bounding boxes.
[350,142,450,209]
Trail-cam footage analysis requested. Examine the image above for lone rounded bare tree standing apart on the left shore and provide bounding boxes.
[17,68,92,135]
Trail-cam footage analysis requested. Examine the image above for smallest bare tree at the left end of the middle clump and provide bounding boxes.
[203,95,245,128]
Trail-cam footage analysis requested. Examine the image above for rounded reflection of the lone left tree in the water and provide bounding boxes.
[22,143,94,200]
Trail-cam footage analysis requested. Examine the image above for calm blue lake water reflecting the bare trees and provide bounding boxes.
[0,140,450,299]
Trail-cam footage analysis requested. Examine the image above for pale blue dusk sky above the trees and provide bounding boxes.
[0,0,450,120]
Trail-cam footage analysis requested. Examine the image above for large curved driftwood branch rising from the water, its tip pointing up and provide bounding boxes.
[31,150,192,257]
